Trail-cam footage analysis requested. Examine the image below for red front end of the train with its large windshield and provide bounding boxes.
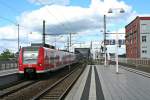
[18,47,44,76]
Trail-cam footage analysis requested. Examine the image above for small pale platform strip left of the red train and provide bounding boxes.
[0,68,18,77]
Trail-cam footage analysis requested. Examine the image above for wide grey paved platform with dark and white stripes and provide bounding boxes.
[65,65,150,100]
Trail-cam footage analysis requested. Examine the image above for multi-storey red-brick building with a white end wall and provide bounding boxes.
[125,16,150,58]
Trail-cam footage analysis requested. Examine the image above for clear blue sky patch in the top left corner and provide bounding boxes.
[0,0,39,26]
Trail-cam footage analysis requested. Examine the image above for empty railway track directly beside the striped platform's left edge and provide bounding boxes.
[32,64,84,100]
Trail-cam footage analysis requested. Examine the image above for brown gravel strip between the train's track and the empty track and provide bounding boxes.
[3,65,83,100]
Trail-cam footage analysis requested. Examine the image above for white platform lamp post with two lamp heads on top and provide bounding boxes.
[108,8,125,73]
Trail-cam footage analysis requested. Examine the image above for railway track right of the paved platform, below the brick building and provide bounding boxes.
[119,66,150,78]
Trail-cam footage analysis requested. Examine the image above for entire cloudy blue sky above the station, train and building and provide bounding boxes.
[0,0,150,54]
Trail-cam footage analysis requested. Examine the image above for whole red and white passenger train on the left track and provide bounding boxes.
[18,44,76,75]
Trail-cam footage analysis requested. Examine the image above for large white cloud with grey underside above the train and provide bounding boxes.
[20,5,95,34]
